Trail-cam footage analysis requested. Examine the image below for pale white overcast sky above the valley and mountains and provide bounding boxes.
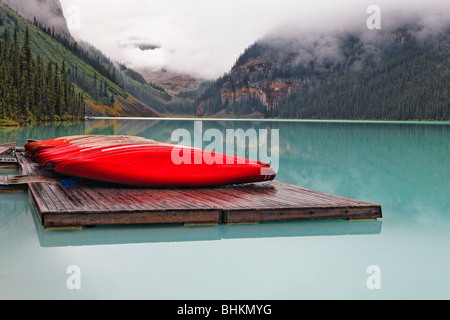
[60,0,450,79]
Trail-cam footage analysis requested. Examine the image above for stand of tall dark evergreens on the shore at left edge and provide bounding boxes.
[0,28,84,122]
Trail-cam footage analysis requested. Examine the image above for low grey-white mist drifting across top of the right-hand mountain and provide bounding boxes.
[258,6,450,72]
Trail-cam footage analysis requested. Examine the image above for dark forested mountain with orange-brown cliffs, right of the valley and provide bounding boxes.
[197,25,450,120]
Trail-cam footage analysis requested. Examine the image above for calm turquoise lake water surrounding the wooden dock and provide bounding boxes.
[0,119,450,300]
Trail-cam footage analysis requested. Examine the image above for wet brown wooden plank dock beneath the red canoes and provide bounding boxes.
[0,150,382,229]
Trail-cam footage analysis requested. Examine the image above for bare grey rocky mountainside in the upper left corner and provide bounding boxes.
[1,0,74,41]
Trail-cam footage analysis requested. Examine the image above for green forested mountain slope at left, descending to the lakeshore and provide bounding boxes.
[0,3,163,122]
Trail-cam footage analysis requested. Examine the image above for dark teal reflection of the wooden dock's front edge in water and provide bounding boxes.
[33,219,382,247]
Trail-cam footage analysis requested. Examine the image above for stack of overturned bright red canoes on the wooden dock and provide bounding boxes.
[25,135,276,187]
